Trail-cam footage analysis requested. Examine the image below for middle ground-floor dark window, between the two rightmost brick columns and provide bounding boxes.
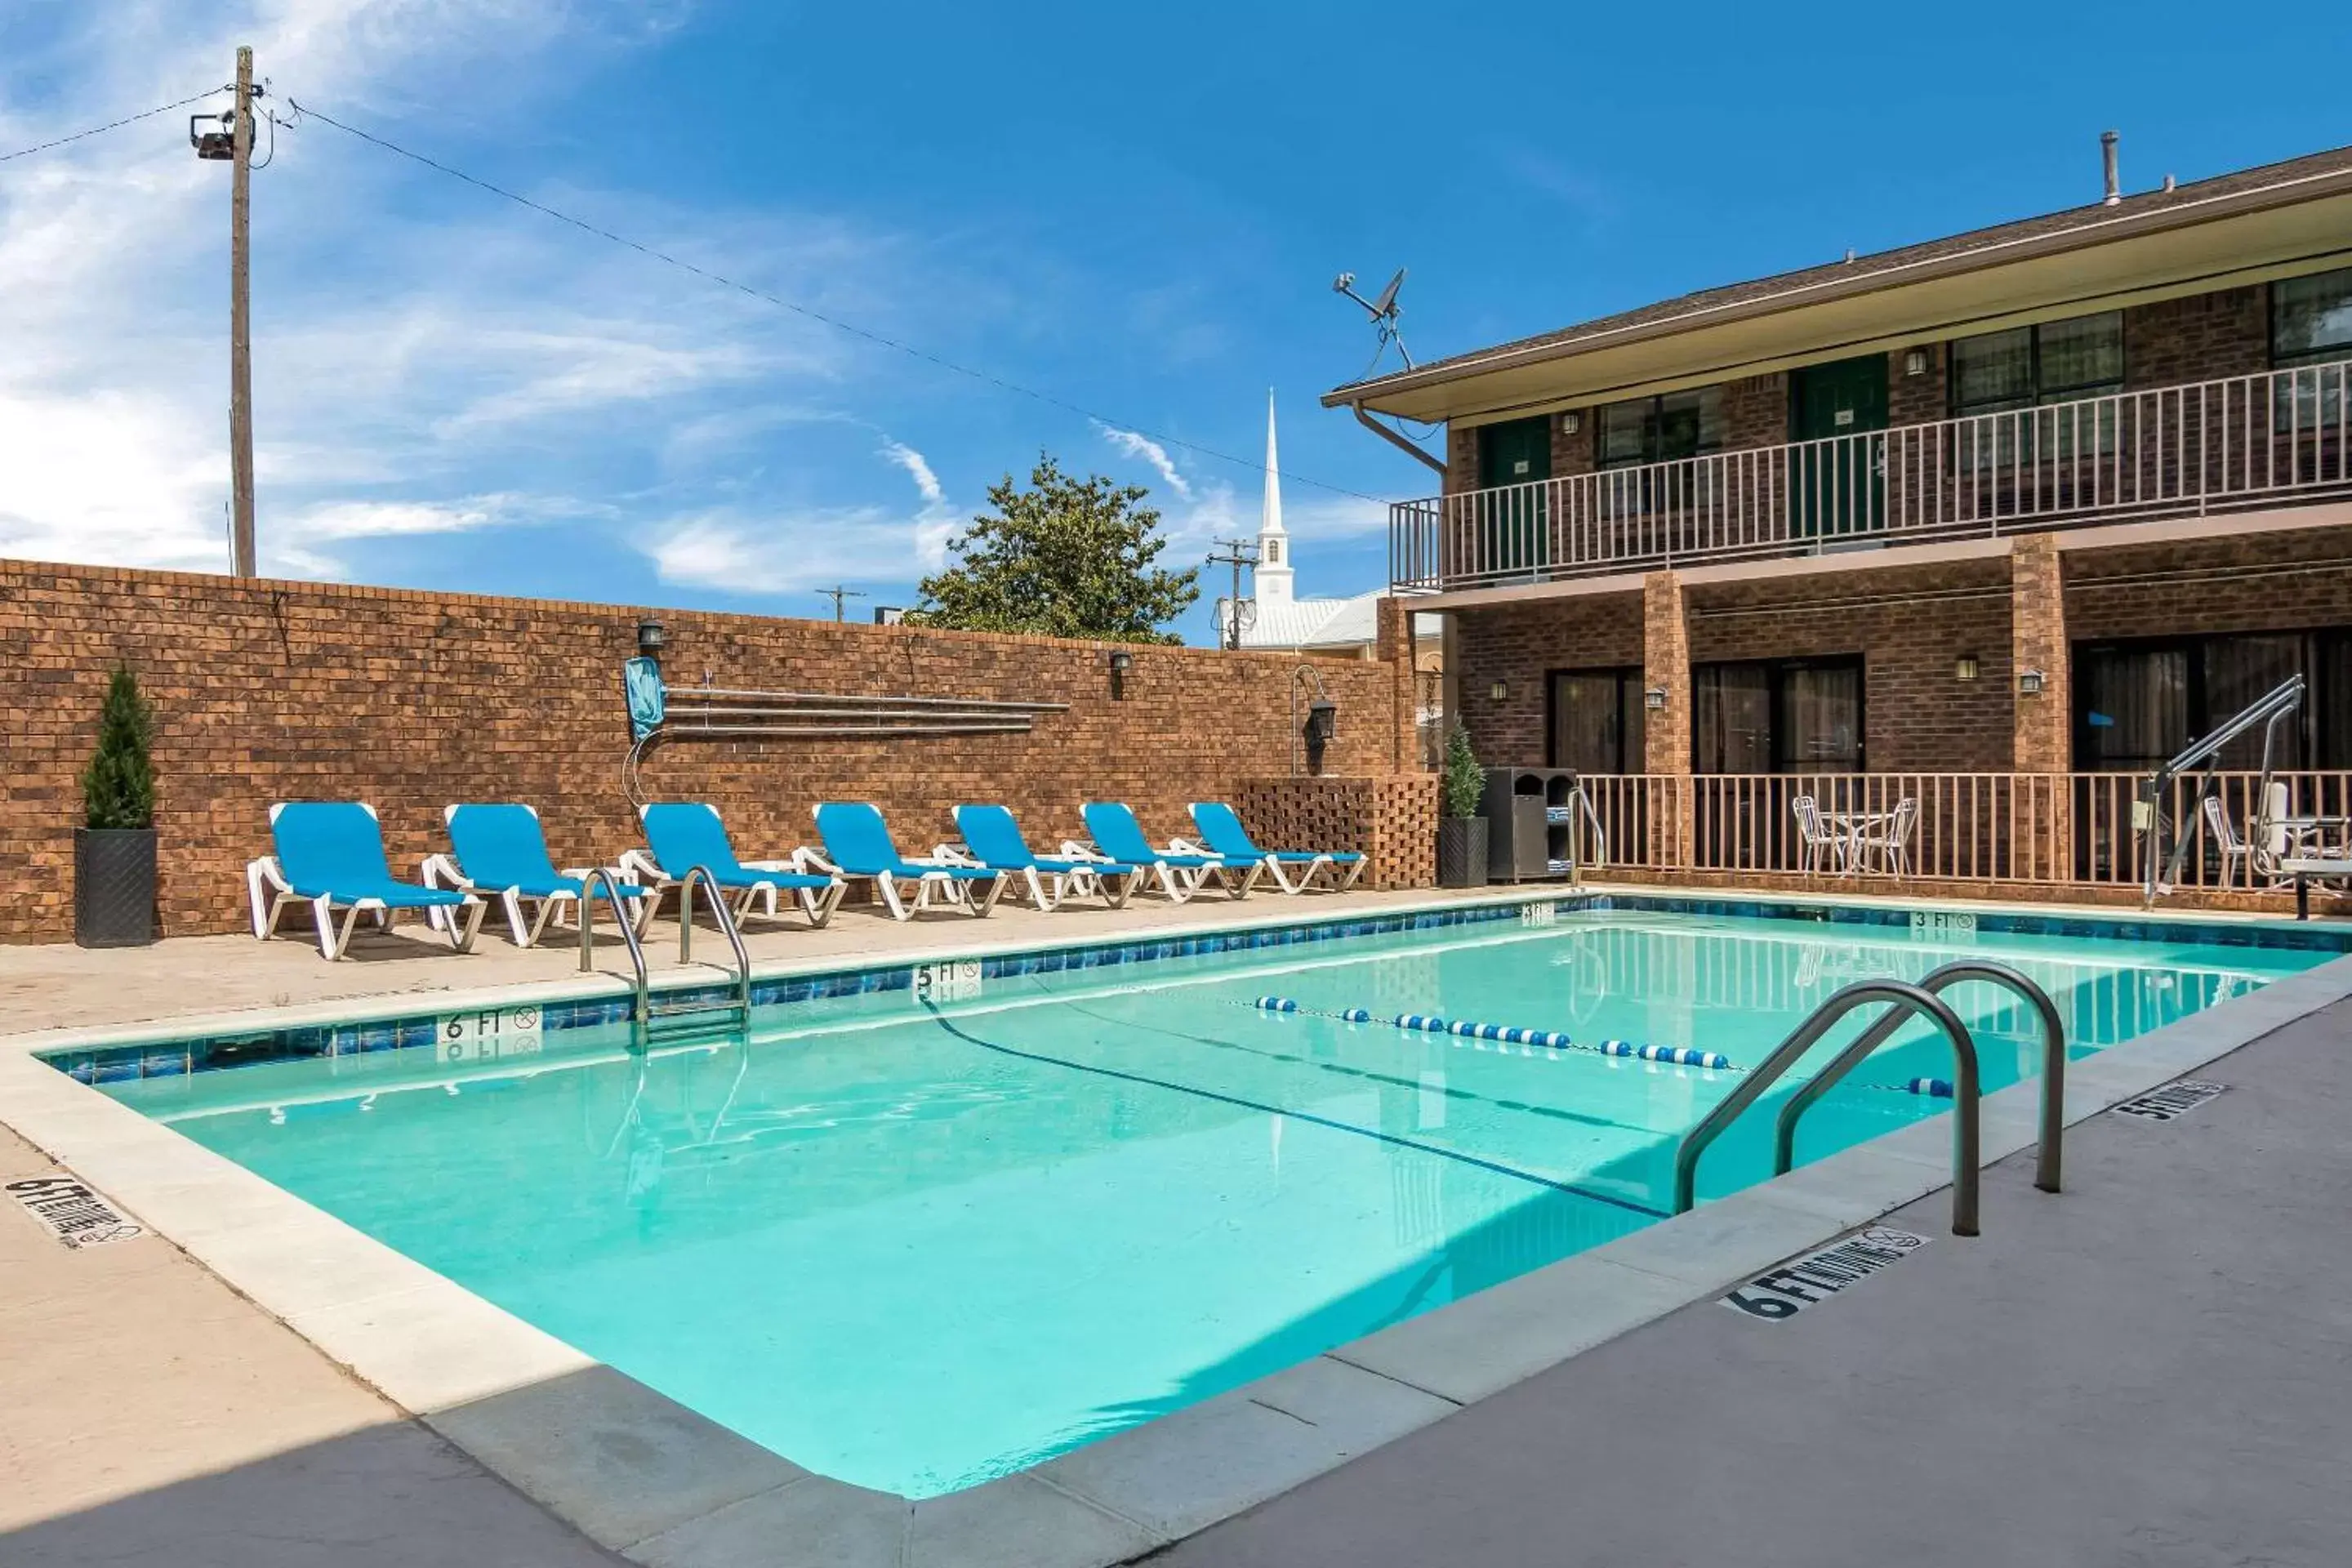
[1691,658,1863,773]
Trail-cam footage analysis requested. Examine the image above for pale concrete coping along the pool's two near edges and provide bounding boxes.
[0,893,2352,1568]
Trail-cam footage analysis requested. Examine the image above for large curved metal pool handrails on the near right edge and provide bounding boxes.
[1675,959,2065,1236]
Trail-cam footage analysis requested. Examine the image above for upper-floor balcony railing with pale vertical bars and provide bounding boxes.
[1388,362,2352,592]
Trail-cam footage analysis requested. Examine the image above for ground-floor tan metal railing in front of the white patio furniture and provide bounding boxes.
[1583,771,2352,893]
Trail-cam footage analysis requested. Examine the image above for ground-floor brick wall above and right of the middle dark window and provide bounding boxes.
[1686,559,2011,773]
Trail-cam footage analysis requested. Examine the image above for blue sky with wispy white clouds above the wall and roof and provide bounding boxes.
[0,0,2352,639]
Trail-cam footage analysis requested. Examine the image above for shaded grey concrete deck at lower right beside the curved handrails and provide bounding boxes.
[1155,1004,2352,1568]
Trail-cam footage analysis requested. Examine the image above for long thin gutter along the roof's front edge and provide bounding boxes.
[1322,167,2352,411]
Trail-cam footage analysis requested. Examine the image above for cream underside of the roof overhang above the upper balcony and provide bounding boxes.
[1322,167,2352,423]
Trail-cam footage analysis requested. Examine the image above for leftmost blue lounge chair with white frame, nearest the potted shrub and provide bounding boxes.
[245,800,487,961]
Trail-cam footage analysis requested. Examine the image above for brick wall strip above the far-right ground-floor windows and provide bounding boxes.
[2069,529,2352,644]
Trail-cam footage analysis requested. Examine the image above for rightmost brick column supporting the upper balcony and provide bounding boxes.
[2009,533,2074,877]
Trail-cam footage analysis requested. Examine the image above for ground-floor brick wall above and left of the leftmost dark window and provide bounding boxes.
[1454,592,1642,766]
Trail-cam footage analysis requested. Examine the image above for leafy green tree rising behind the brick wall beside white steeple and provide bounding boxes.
[906,452,1200,642]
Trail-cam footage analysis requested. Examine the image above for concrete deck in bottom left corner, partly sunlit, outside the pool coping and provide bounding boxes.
[0,1131,621,1568]
